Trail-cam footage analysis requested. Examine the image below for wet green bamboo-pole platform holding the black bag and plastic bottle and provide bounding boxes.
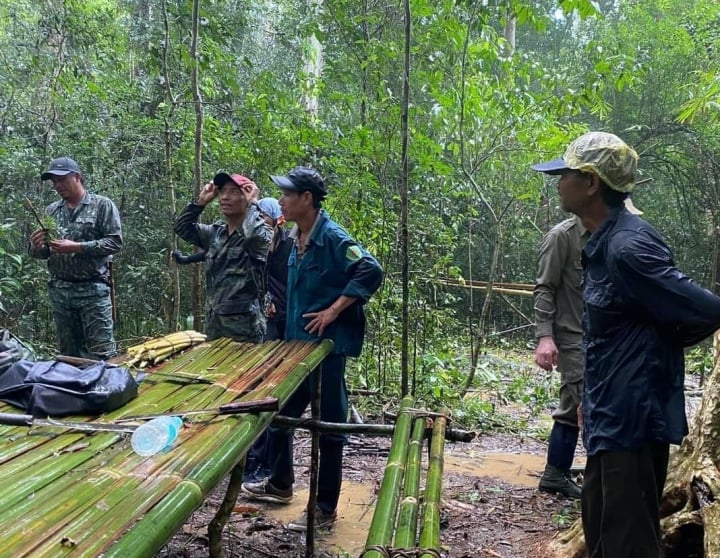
[0,339,332,558]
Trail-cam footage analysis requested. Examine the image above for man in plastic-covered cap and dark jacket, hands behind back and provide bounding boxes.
[533,132,720,558]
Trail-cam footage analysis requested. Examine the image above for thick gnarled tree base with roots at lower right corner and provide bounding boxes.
[539,332,720,558]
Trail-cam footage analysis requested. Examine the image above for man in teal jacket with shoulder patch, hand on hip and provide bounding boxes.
[242,167,382,531]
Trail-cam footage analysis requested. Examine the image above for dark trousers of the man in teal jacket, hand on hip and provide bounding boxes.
[270,355,348,513]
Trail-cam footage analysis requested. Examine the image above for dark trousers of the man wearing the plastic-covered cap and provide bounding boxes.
[582,442,669,558]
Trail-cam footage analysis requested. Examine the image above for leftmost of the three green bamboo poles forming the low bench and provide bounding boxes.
[363,395,414,558]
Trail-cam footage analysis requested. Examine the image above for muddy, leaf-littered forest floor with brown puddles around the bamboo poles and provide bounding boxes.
[157,426,582,558]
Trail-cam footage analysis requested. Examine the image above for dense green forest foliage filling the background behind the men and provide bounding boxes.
[0,0,720,402]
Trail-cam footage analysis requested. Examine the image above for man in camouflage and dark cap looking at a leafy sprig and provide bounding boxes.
[30,157,122,360]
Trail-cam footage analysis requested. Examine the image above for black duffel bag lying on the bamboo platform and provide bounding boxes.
[0,360,138,417]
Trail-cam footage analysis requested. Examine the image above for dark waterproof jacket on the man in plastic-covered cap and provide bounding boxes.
[582,207,720,455]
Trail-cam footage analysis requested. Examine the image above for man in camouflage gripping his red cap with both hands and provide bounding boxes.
[174,173,273,343]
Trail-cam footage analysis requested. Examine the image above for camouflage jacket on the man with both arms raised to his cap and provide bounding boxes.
[174,203,272,314]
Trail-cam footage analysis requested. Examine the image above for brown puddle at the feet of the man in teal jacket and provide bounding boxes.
[265,481,375,556]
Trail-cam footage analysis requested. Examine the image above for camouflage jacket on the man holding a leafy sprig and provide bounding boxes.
[30,192,122,283]
